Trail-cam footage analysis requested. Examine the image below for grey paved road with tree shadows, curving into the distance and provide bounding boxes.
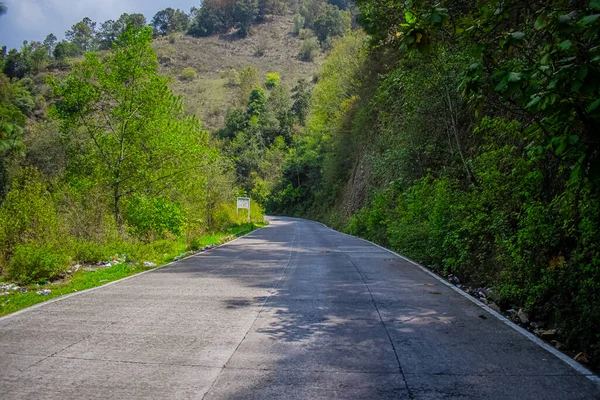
[0,218,600,400]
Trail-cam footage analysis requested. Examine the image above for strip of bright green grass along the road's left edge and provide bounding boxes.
[0,223,266,316]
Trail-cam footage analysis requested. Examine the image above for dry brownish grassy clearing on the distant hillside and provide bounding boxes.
[154,15,324,130]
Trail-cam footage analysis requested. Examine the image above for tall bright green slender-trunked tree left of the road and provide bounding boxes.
[52,26,208,227]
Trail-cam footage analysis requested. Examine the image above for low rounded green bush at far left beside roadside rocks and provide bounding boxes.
[7,242,69,283]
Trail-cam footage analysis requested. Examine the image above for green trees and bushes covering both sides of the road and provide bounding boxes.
[0,0,600,368]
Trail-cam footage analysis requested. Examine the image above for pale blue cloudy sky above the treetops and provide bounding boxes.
[0,0,200,48]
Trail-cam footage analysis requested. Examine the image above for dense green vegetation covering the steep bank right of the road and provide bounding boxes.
[266,0,600,367]
